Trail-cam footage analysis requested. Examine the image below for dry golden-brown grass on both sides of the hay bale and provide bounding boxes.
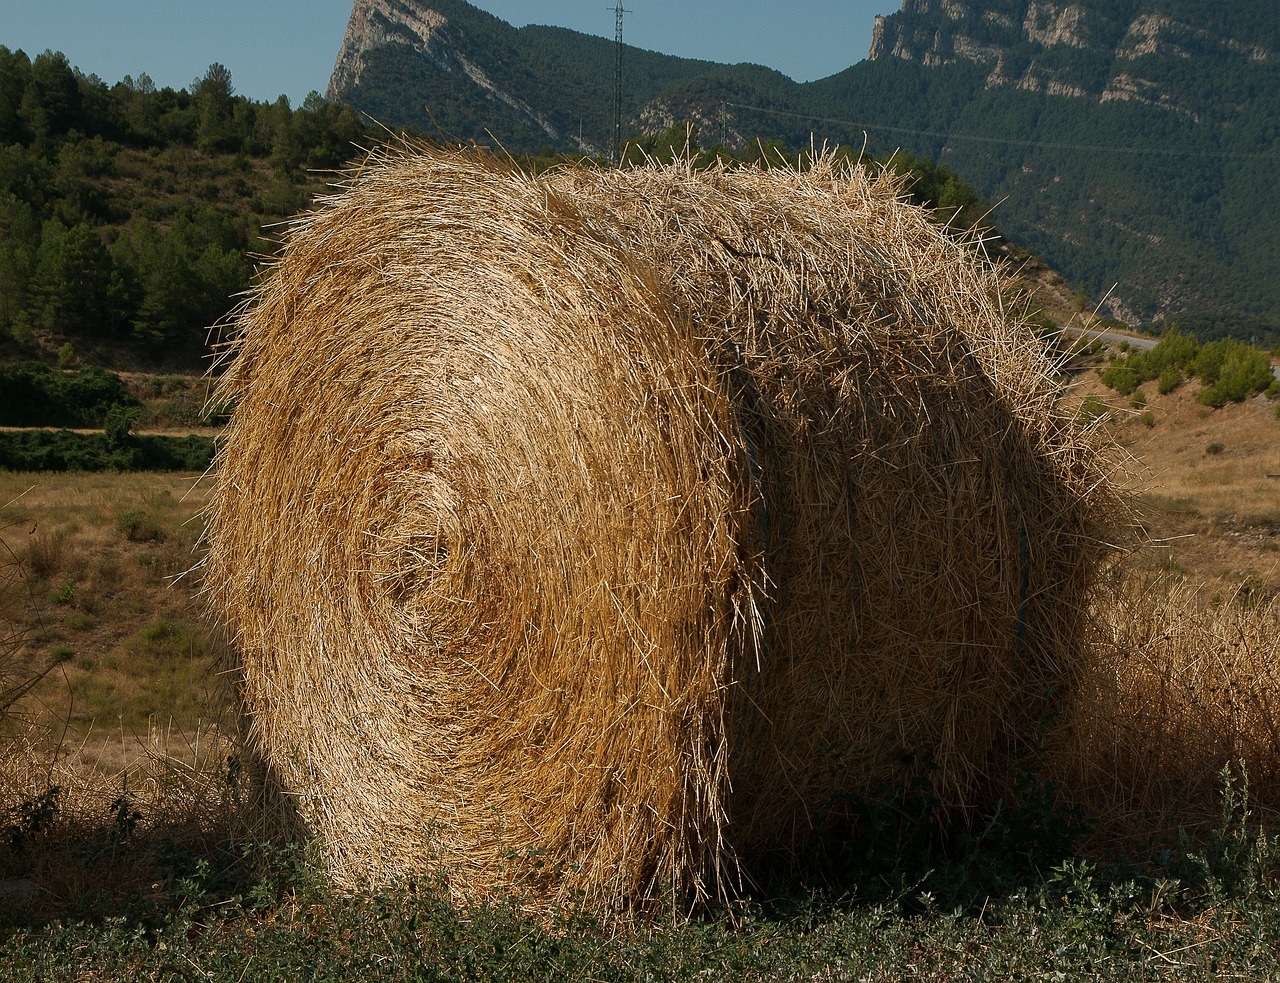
[0,348,1280,931]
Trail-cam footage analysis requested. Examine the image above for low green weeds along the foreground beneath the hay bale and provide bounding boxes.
[0,762,1280,983]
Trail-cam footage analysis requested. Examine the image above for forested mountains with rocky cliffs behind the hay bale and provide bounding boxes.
[328,0,1280,344]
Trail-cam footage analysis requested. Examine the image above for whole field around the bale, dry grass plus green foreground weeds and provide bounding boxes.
[0,358,1280,980]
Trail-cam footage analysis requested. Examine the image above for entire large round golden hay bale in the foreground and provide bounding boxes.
[206,148,1112,907]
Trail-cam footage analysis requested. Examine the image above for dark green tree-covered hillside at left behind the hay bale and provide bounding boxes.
[0,47,369,369]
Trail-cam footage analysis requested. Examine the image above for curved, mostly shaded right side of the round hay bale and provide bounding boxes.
[547,157,1117,861]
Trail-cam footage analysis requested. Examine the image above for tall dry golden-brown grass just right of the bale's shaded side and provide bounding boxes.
[1055,579,1280,851]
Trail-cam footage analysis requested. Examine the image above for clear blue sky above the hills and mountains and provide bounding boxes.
[0,0,901,105]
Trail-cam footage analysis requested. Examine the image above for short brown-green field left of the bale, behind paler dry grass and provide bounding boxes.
[0,472,223,774]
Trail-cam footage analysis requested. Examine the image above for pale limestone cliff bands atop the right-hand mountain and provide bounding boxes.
[868,0,1276,113]
